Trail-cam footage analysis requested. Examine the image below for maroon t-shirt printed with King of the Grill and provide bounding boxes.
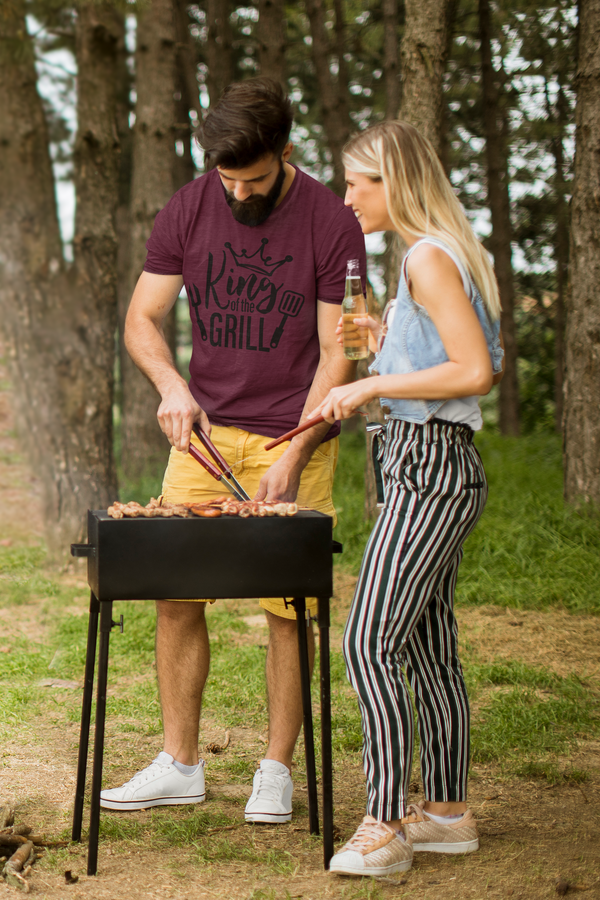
[144,169,366,438]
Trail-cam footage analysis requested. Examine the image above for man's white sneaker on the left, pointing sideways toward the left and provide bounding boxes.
[100,750,206,809]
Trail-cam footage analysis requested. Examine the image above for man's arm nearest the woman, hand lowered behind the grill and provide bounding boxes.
[255,300,356,502]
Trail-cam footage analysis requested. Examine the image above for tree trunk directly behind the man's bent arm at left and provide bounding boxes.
[120,0,178,481]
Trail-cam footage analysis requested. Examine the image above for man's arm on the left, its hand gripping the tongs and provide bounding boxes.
[125,272,210,453]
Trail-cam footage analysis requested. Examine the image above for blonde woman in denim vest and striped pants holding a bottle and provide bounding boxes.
[314,122,503,875]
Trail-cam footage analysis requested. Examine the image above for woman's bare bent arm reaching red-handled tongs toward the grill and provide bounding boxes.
[314,244,493,419]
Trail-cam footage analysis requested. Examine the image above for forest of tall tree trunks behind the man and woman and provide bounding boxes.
[0,0,600,549]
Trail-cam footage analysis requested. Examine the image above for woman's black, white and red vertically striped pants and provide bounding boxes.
[343,419,487,821]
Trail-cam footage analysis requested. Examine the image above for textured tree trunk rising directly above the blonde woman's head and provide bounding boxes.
[400,0,450,153]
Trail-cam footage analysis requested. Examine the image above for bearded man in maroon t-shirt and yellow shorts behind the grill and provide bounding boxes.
[101,78,365,822]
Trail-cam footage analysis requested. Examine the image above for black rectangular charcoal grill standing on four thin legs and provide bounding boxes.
[71,510,342,875]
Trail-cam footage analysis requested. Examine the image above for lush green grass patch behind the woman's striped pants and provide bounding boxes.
[335,433,600,614]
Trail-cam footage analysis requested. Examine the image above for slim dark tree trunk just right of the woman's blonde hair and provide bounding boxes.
[479,0,519,435]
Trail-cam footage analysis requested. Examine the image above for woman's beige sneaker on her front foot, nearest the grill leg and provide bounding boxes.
[329,816,412,875]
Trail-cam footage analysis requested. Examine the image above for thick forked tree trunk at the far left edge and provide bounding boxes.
[0,2,119,553]
